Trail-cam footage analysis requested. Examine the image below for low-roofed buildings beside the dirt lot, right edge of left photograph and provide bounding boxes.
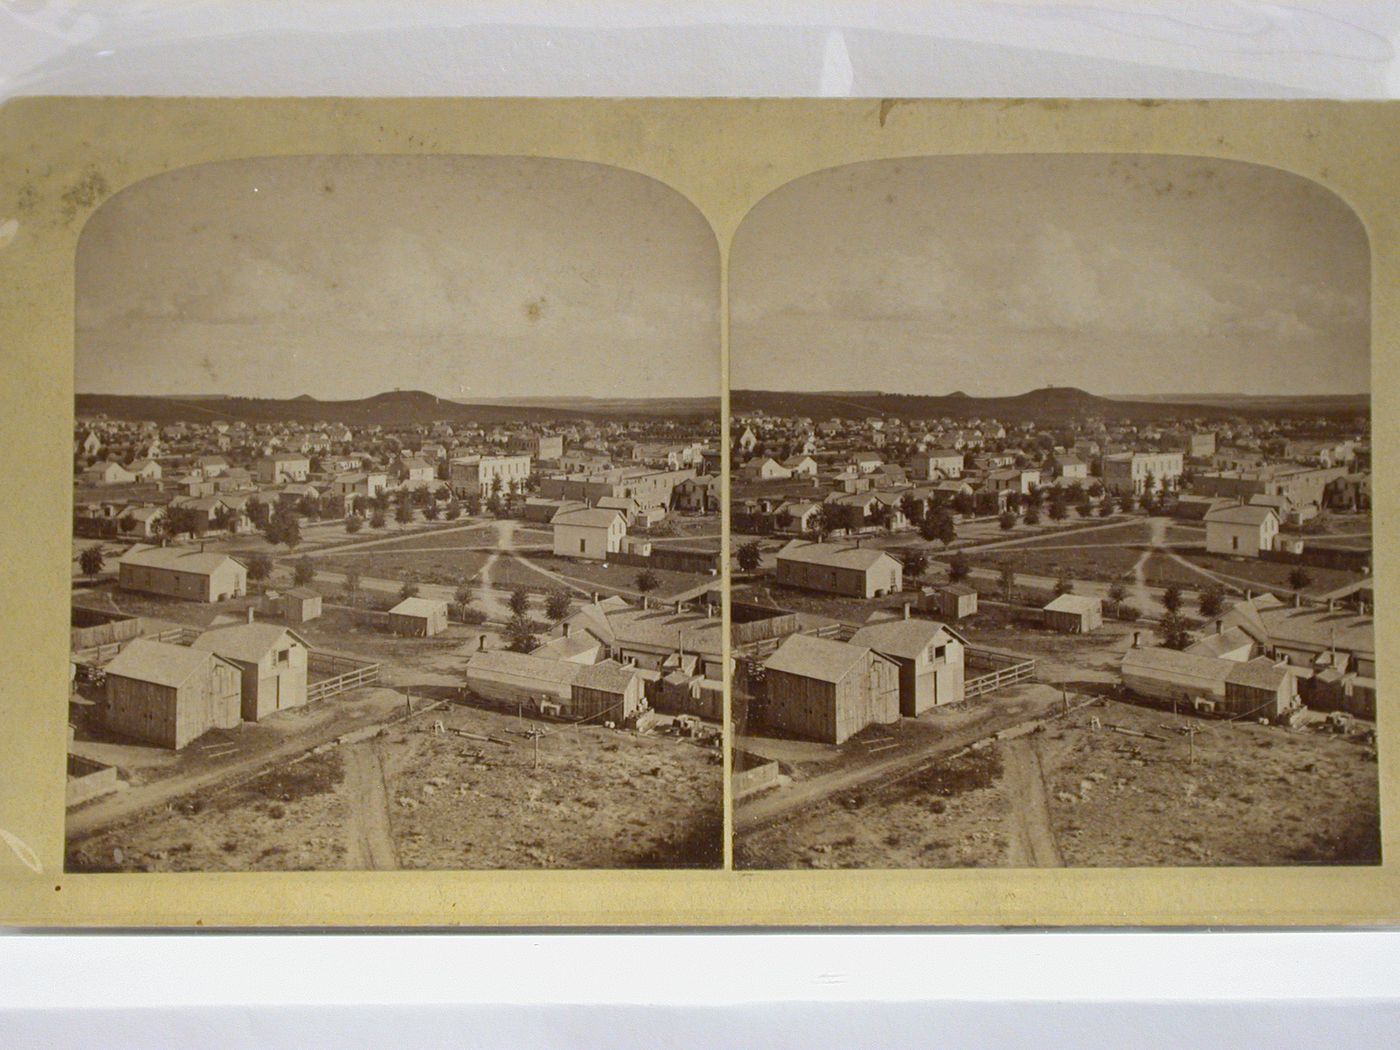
[466,596,724,725]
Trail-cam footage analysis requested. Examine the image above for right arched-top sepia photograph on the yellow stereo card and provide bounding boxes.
[728,154,1380,869]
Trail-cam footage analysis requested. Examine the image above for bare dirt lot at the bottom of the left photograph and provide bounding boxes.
[67,706,722,871]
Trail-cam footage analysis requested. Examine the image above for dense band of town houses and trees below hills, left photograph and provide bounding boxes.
[74,419,720,549]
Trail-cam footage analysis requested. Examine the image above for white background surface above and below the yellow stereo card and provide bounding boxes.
[0,0,1400,1050]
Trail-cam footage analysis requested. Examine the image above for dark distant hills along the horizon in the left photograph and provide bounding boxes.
[76,391,720,426]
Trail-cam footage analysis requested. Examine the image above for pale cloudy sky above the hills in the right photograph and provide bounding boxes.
[729,154,1371,396]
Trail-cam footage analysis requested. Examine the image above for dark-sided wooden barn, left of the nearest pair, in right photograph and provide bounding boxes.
[762,634,899,743]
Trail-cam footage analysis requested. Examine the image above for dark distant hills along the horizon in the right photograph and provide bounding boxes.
[729,386,1371,423]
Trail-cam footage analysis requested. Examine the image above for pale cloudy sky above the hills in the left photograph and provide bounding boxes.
[76,157,720,400]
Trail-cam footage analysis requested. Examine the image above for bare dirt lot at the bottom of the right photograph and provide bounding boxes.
[735,701,1380,868]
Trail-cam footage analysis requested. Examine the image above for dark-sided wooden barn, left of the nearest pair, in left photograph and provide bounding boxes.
[105,638,241,750]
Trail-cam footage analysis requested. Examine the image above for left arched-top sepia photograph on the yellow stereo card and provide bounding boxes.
[66,155,724,872]
